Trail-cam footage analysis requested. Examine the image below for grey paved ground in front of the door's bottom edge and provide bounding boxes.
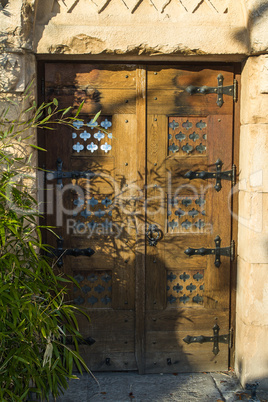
[50,372,268,402]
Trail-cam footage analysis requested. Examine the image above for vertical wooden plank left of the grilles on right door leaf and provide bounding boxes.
[146,114,168,311]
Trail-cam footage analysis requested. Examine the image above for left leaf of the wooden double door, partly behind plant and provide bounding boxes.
[42,63,138,370]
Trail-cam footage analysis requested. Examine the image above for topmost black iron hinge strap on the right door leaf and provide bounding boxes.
[185,74,237,107]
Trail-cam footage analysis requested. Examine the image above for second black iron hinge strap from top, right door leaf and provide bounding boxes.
[184,159,236,191]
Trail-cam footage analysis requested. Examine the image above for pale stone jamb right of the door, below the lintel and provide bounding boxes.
[236,53,268,388]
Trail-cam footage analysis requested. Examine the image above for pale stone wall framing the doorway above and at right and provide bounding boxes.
[0,0,268,387]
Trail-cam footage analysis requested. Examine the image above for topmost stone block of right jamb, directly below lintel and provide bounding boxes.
[241,55,268,124]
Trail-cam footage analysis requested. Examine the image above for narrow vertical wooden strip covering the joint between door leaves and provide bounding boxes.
[135,66,146,374]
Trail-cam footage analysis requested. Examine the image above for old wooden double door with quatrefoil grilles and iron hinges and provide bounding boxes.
[39,63,236,373]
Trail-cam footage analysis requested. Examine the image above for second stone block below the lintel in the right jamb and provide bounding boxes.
[238,123,268,192]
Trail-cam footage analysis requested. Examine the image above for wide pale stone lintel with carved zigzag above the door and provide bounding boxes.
[34,0,248,56]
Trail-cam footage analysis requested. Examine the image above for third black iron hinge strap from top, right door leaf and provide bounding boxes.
[184,236,235,268]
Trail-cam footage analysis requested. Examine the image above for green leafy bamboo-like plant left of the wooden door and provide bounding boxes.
[0,86,96,402]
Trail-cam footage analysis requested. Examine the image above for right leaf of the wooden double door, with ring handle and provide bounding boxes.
[146,67,233,372]
